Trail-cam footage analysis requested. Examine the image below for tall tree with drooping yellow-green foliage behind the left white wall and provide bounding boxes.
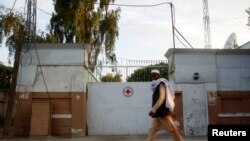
[50,0,120,71]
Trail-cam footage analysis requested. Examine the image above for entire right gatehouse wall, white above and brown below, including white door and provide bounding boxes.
[166,49,250,135]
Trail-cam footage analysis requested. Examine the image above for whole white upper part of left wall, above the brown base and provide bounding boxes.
[16,44,97,93]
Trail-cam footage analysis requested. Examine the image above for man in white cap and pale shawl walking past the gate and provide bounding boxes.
[147,69,183,141]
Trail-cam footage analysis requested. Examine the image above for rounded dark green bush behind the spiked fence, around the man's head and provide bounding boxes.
[127,62,168,82]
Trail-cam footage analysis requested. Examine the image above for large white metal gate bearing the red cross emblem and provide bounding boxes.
[87,82,152,135]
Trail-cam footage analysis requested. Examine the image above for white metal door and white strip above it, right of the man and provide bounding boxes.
[174,83,217,136]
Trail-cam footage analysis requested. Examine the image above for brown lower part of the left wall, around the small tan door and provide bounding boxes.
[15,92,86,137]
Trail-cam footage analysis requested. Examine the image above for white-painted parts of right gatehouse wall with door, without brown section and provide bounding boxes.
[165,49,250,135]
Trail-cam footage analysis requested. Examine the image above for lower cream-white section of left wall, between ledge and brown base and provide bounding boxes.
[17,65,96,92]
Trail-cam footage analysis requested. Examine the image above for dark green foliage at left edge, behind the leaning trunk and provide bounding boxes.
[0,63,13,89]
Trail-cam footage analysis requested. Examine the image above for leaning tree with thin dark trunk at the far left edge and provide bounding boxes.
[0,4,25,136]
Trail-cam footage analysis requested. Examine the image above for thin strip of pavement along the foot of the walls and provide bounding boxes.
[0,135,207,141]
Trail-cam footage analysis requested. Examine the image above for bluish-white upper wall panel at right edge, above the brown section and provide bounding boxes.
[217,54,250,91]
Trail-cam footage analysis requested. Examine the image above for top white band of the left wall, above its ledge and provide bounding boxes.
[21,43,84,66]
